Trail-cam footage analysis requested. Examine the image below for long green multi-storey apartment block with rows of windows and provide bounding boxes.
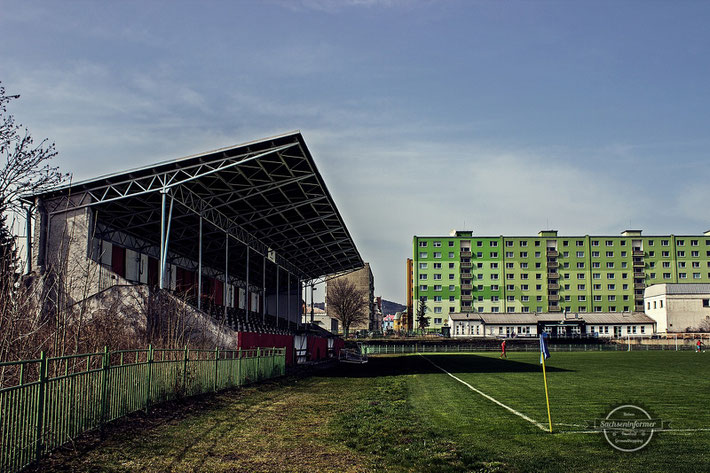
[411,230,710,329]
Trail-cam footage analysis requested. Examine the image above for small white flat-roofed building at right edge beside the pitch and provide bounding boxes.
[643,283,710,333]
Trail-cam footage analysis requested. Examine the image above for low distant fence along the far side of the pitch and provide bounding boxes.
[360,343,695,355]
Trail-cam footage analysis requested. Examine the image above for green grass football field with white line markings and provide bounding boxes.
[37,352,710,473]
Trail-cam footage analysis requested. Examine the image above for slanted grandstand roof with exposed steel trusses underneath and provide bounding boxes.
[25,132,363,280]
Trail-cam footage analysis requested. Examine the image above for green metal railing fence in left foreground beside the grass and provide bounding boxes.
[0,347,286,472]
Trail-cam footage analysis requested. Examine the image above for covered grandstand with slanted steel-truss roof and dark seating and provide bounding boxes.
[24,132,363,359]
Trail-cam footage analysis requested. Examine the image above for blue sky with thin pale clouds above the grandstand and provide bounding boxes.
[0,0,710,303]
